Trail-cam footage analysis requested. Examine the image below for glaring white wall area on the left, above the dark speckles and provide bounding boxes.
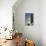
[0,0,16,29]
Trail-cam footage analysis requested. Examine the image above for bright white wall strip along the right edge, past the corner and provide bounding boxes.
[41,0,46,46]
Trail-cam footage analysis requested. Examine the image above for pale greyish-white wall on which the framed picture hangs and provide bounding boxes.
[14,0,41,46]
